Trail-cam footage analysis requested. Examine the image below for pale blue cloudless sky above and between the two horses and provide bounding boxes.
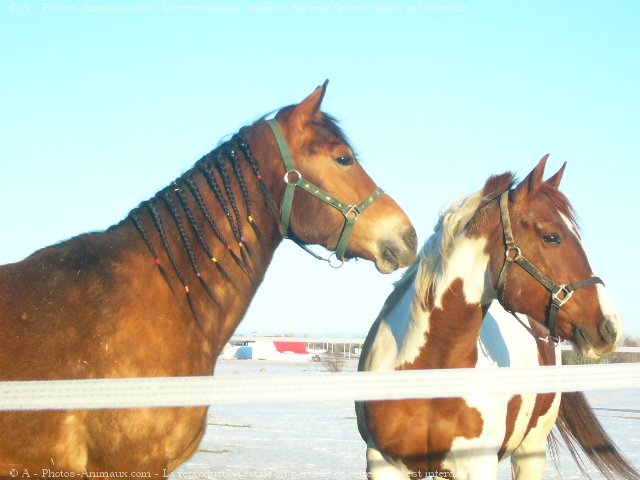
[0,0,640,335]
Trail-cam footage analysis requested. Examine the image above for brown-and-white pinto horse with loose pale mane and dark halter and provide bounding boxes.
[356,156,638,480]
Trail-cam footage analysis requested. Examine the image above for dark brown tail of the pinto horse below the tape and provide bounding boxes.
[549,392,640,480]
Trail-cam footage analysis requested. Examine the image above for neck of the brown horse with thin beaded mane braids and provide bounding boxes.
[112,120,284,354]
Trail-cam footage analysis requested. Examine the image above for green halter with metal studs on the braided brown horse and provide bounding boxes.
[267,119,384,268]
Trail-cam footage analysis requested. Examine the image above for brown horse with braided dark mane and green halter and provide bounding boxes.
[0,83,417,478]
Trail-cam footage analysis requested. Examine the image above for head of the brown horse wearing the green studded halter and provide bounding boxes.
[262,82,417,273]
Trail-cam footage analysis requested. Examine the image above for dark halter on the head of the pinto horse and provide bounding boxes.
[496,190,604,343]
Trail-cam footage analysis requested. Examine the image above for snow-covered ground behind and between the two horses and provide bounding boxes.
[172,360,640,480]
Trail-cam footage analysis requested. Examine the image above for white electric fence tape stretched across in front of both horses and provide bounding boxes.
[0,363,640,411]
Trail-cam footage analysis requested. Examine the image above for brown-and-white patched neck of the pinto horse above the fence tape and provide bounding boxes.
[402,231,492,369]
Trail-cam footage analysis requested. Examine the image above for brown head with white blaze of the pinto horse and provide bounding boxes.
[485,155,621,358]
